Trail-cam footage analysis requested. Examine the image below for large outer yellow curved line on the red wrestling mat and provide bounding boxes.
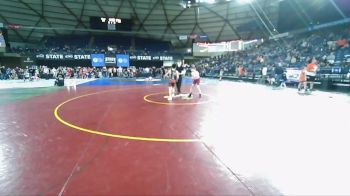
[54,88,201,142]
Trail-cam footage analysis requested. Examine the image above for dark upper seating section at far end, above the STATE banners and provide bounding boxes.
[11,36,174,56]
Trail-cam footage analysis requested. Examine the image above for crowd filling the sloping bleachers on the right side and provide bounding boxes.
[197,28,350,77]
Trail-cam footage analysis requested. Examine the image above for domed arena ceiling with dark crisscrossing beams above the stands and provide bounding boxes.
[0,0,280,44]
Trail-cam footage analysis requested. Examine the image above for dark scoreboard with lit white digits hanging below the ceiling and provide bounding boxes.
[90,17,132,31]
